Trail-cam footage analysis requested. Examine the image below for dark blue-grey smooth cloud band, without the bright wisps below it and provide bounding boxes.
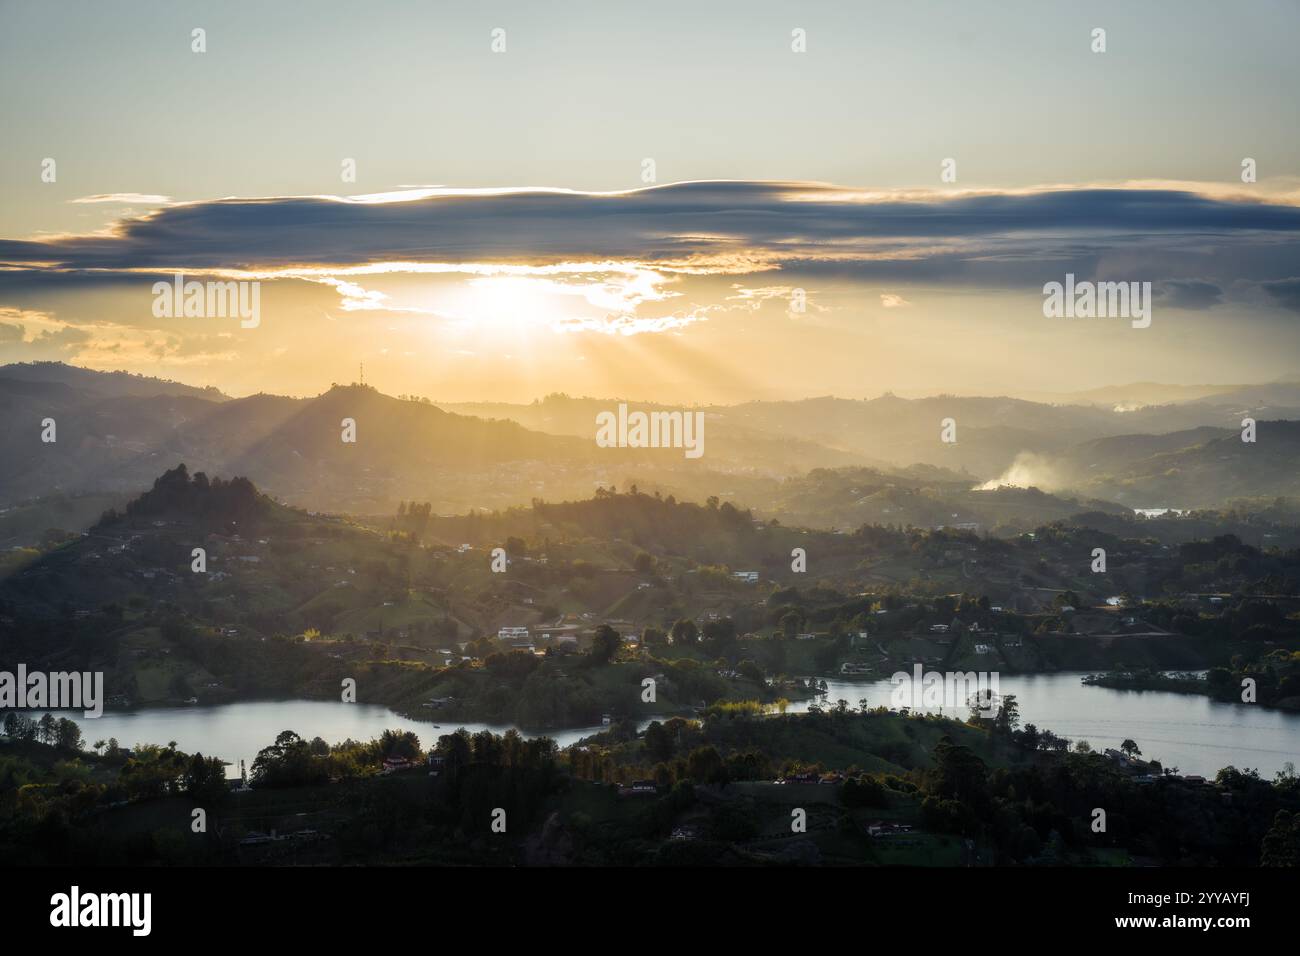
[0,182,1300,278]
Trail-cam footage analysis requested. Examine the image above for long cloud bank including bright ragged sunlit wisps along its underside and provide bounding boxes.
[0,181,1300,334]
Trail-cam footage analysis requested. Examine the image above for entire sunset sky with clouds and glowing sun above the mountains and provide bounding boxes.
[0,0,1300,403]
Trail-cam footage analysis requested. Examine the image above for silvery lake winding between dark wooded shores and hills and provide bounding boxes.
[38,674,1300,778]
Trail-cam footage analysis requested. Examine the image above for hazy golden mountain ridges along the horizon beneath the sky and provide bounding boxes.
[0,363,1300,525]
